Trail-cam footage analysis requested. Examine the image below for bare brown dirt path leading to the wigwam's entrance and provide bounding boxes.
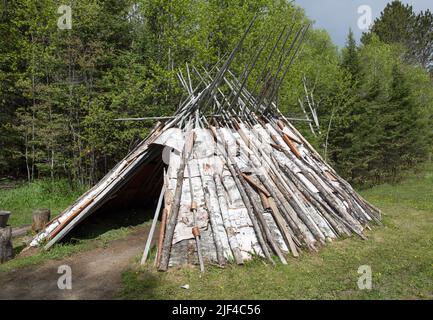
[0,227,154,299]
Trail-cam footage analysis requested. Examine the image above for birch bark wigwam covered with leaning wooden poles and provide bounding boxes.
[27,15,381,271]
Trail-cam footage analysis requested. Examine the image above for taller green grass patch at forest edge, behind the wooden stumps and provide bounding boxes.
[0,180,84,227]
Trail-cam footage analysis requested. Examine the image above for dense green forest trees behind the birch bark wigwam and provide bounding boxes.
[0,0,433,185]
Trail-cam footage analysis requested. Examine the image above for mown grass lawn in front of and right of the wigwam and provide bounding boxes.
[121,166,433,299]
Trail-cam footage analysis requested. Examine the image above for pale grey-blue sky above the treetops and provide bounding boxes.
[295,0,433,47]
